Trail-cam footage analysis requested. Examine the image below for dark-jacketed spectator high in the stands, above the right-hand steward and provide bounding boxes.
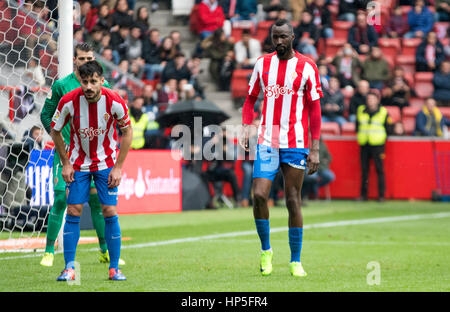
[343,11,378,54]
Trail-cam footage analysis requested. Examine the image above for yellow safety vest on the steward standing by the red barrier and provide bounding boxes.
[356,105,388,146]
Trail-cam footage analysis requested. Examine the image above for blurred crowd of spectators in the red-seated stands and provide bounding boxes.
[0,0,450,206]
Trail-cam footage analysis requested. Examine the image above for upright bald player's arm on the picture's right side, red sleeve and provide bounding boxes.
[306,64,323,174]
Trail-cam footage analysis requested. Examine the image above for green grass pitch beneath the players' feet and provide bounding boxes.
[0,201,450,292]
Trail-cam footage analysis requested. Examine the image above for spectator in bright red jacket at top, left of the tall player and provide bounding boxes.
[198,0,225,40]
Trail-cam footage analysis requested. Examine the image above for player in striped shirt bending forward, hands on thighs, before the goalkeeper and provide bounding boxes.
[51,61,133,281]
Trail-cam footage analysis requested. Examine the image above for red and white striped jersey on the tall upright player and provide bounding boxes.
[243,51,323,148]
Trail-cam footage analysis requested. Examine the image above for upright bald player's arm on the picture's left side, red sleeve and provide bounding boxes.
[239,58,263,152]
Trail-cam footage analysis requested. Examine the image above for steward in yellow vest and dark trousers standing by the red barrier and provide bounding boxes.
[356,92,391,202]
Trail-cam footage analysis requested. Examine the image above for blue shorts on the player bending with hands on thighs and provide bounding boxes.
[67,167,117,206]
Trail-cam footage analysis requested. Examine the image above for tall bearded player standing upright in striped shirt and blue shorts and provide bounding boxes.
[240,20,322,276]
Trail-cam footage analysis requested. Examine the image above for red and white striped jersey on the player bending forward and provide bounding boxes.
[51,87,131,171]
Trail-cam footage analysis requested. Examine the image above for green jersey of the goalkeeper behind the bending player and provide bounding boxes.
[41,73,111,145]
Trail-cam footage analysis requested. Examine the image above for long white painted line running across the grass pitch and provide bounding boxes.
[0,212,450,261]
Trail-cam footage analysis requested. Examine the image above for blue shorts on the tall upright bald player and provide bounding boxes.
[253,144,309,181]
